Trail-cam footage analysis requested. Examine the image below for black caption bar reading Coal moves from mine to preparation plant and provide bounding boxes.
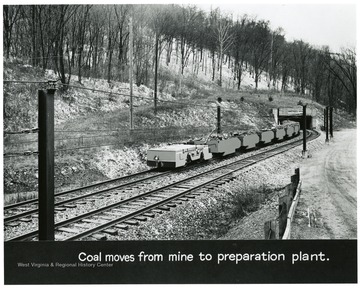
[4,240,357,284]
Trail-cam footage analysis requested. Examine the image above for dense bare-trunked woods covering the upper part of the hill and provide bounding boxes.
[3,4,357,115]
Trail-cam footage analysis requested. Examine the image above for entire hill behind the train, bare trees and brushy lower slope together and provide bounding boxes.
[3,5,356,203]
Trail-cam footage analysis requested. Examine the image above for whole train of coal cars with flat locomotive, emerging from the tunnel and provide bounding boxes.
[147,122,300,168]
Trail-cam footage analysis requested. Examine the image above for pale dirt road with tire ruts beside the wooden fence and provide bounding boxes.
[291,129,357,239]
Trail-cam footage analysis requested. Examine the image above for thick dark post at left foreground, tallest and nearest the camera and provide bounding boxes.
[38,89,55,241]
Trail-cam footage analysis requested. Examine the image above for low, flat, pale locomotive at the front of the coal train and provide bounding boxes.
[147,144,212,168]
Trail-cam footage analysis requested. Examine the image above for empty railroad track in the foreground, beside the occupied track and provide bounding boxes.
[7,131,319,241]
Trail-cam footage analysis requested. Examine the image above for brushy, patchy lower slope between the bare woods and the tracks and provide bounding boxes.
[4,61,354,202]
